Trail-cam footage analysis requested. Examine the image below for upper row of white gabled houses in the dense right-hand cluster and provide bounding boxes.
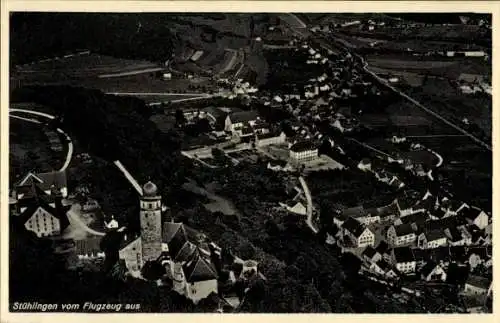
[333,192,492,249]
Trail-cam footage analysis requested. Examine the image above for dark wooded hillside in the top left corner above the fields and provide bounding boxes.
[10,12,176,64]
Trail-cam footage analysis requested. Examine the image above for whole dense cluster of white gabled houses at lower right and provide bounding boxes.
[333,187,492,311]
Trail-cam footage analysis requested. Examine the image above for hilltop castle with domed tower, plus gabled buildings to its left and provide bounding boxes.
[9,172,265,311]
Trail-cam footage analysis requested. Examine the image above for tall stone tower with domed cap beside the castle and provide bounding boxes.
[140,182,161,264]
